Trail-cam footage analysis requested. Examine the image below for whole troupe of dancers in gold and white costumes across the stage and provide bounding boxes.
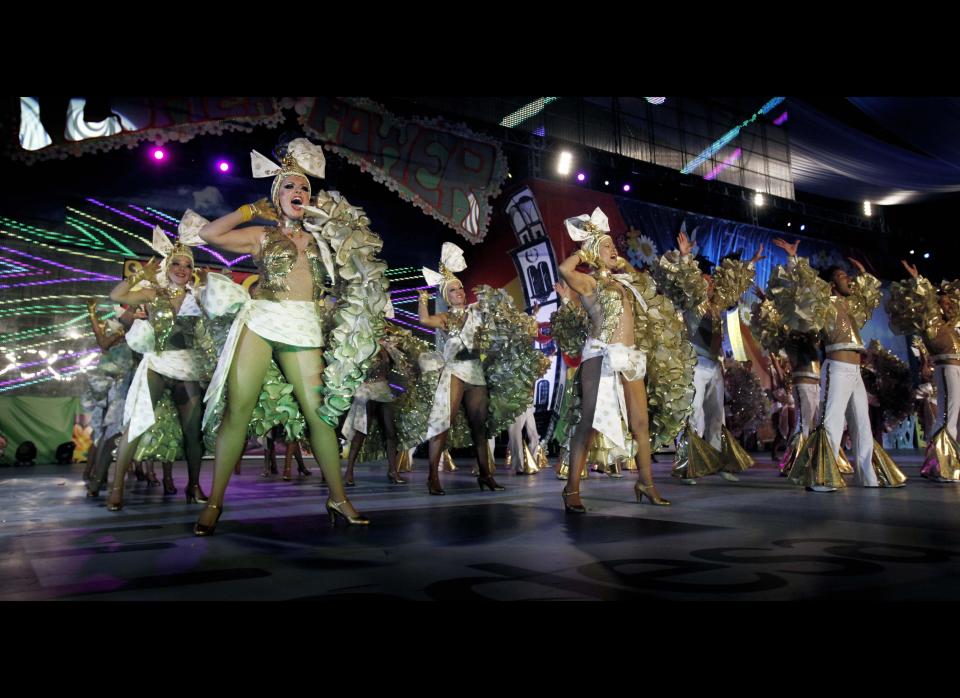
[82,138,960,536]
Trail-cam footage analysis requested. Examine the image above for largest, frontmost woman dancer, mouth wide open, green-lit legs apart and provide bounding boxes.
[191,138,386,536]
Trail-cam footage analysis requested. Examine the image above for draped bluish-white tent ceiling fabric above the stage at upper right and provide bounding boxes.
[789,97,960,205]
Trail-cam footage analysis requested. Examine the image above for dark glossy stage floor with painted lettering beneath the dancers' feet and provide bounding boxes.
[0,452,960,601]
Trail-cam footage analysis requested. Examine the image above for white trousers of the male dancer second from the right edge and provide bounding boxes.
[820,359,878,487]
